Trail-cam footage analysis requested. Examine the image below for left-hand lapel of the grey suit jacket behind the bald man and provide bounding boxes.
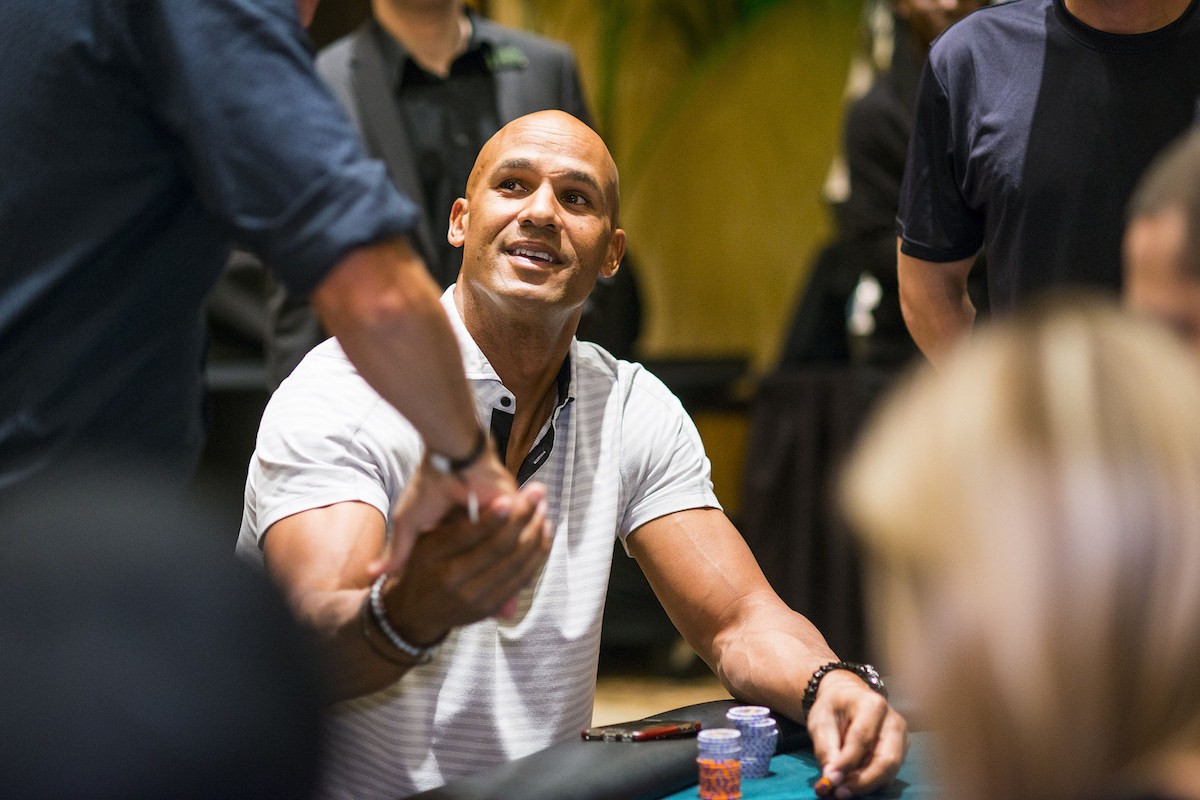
[350,30,434,258]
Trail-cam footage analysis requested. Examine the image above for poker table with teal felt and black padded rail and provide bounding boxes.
[414,700,935,800]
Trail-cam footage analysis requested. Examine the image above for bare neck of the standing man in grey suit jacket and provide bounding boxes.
[371,0,470,78]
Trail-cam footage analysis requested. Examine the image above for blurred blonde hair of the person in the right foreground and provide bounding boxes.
[842,301,1200,800]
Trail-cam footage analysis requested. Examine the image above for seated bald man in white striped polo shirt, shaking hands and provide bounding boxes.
[239,112,907,798]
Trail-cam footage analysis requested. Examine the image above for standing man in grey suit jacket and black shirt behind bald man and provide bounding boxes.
[266,0,641,386]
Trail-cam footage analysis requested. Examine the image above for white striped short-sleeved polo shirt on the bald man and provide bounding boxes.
[238,287,720,799]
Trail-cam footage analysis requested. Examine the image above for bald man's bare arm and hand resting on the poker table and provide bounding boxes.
[629,509,907,793]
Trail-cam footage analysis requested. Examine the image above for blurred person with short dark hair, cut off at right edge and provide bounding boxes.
[1124,128,1200,355]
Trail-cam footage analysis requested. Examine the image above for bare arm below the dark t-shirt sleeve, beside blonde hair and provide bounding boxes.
[896,246,976,366]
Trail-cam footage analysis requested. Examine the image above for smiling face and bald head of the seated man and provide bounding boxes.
[449,112,625,321]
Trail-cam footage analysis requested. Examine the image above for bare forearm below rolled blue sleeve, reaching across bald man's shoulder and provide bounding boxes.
[312,240,479,457]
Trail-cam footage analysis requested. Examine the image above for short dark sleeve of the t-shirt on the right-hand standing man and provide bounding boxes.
[896,56,984,261]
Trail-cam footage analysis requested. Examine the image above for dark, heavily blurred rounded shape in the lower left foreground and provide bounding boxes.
[0,464,326,800]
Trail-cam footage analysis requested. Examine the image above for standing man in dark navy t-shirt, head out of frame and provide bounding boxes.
[898,0,1200,362]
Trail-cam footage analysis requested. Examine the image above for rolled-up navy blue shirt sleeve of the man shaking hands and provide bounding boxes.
[122,0,418,294]
